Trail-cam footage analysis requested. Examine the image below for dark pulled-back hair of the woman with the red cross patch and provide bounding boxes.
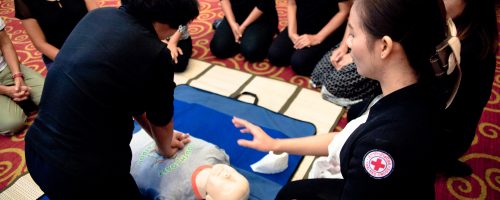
[355,0,447,80]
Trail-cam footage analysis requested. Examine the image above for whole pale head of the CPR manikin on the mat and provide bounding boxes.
[191,164,250,200]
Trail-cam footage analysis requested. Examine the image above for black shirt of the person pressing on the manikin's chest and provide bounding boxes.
[26,8,175,176]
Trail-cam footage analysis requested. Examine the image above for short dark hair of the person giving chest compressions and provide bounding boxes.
[122,0,199,28]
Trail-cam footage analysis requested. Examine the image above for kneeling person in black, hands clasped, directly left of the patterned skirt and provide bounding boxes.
[268,0,352,76]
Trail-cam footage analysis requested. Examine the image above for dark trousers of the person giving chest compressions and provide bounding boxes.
[25,145,141,200]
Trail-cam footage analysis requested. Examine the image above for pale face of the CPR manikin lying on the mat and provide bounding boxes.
[206,164,249,200]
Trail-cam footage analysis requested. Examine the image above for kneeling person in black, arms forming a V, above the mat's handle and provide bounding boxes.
[210,0,278,62]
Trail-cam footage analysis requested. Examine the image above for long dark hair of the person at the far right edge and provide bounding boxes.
[454,0,498,59]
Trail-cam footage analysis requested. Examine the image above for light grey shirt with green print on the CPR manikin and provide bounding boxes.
[130,132,229,199]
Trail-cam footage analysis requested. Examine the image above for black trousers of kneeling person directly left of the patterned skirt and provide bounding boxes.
[268,25,345,76]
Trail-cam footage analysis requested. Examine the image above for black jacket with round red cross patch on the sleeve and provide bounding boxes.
[340,85,435,199]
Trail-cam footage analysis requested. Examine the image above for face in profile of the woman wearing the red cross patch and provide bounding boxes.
[347,1,377,80]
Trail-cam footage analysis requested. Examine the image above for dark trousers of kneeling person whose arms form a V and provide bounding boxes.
[210,18,278,62]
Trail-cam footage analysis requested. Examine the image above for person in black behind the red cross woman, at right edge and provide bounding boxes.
[440,0,498,176]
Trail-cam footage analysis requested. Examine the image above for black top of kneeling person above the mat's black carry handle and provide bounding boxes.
[231,0,278,25]
